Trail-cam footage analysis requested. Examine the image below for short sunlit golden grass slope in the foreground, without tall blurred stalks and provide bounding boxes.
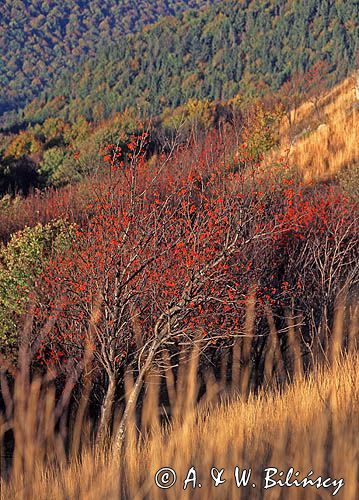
[1,355,359,500]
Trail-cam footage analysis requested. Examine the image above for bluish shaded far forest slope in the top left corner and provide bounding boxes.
[0,0,219,121]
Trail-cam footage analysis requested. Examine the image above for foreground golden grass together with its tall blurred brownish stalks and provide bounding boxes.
[0,290,359,500]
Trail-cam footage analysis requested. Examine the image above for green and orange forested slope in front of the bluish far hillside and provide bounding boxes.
[24,0,359,125]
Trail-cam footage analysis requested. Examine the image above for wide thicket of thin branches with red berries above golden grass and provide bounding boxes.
[0,122,359,446]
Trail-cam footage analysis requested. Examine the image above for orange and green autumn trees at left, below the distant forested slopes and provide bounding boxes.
[0,109,148,189]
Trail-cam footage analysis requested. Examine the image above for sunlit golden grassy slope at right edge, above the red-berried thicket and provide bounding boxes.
[280,77,359,182]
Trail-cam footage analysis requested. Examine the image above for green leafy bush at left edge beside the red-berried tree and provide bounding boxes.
[0,220,74,348]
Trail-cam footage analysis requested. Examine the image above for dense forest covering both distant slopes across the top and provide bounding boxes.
[0,0,359,129]
